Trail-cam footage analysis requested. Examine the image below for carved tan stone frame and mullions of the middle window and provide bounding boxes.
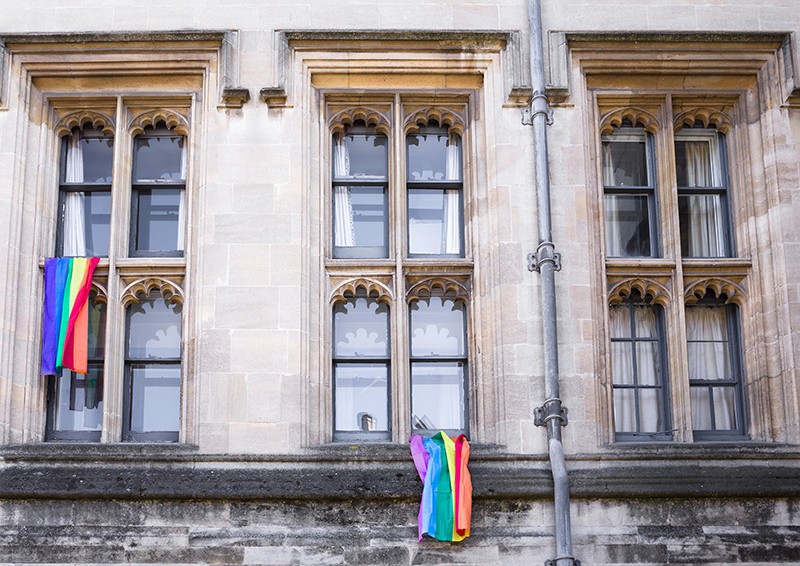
[324,97,474,442]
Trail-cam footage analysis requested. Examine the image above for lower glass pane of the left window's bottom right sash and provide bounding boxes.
[130,364,181,432]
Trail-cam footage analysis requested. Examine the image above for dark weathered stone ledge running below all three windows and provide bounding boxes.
[0,445,800,501]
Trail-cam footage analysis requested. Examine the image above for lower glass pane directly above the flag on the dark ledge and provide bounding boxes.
[411,362,466,430]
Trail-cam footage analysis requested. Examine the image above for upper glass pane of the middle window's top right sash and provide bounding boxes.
[406,128,461,182]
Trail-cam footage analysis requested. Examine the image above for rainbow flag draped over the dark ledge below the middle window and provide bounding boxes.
[411,431,472,541]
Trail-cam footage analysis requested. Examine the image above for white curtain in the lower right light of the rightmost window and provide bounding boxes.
[686,306,736,430]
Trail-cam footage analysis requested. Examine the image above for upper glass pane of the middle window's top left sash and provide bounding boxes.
[333,134,389,180]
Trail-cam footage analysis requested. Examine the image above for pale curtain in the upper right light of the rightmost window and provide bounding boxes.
[684,141,726,257]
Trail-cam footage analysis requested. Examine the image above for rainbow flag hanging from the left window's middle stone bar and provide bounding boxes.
[42,257,100,375]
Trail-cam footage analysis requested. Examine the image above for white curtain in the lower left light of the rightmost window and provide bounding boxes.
[609,304,664,432]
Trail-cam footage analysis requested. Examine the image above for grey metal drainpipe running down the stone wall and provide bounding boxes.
[523,0,580,566]
